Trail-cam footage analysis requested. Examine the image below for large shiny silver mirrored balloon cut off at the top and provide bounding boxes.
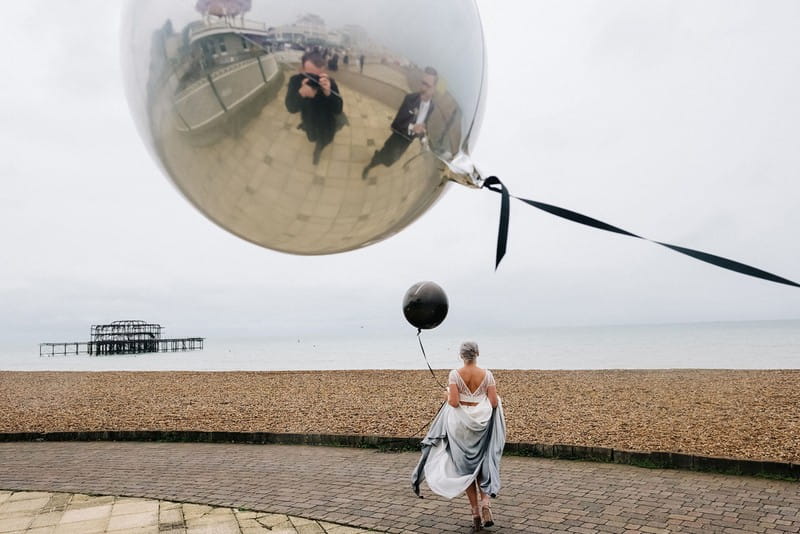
[122,0,485,254]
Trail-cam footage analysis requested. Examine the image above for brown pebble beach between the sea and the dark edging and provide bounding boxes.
[0,369,800,462]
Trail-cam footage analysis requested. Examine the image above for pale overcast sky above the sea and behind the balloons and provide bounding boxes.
[0,0,800,344]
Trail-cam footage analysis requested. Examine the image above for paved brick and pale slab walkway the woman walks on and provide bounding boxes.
[0,442,800,534]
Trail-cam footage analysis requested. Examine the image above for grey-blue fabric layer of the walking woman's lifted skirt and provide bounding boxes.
[411,402,506,497]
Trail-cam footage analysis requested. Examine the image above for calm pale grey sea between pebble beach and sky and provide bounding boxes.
[0,320,800,371]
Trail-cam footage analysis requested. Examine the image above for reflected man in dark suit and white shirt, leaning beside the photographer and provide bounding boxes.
[361,67,439,180]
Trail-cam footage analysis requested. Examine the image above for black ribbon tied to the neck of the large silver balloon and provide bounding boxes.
[483,176,800,287]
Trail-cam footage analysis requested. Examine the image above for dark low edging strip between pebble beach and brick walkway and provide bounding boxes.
[0,430,800,481]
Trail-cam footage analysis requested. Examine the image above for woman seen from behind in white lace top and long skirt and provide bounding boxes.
[411,341,506,532]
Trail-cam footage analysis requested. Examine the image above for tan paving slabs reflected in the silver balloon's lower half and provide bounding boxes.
[156,59,446,254]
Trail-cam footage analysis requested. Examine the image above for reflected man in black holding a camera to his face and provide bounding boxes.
[286,51,343,165]
